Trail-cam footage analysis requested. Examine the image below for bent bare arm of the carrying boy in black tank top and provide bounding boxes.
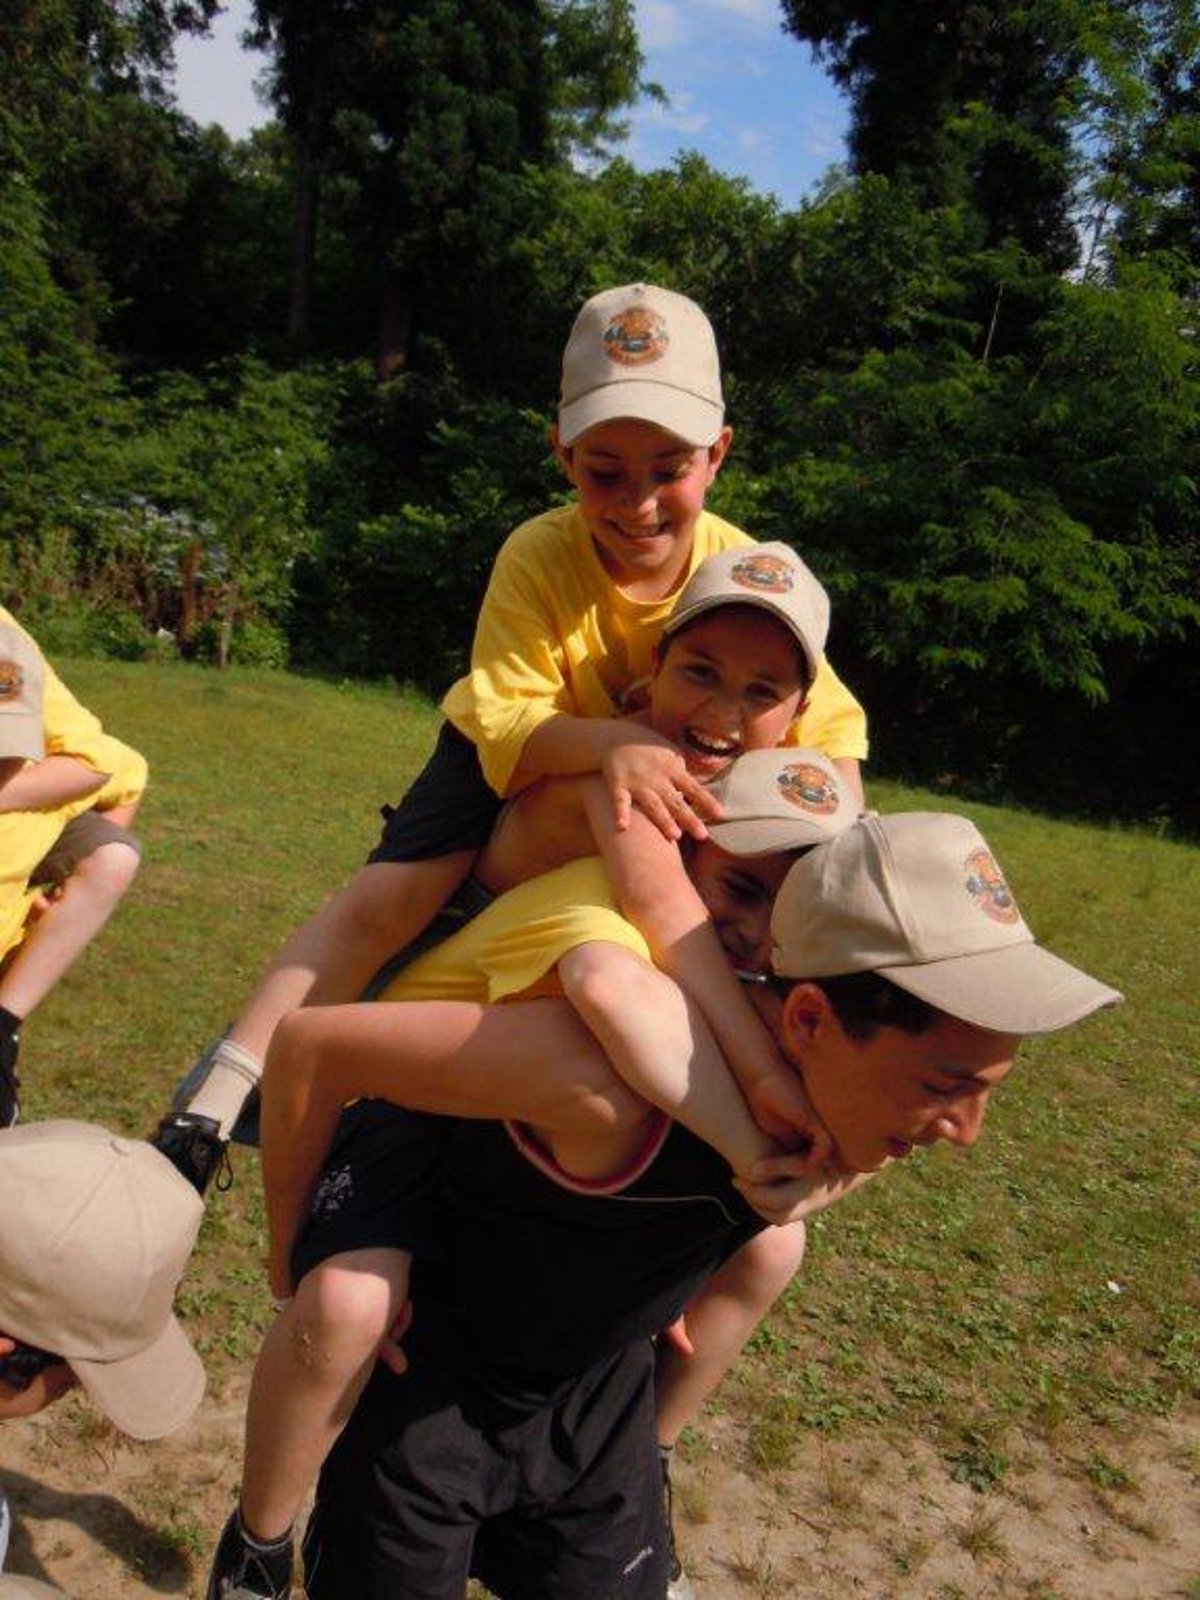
[262,1000,646,1294]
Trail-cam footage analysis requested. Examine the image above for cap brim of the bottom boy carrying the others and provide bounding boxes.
[877,942,1125,1034]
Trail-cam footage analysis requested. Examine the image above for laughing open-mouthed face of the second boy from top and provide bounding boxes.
[650,605,805,782]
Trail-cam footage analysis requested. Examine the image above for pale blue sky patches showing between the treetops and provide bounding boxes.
[176,0,846,206]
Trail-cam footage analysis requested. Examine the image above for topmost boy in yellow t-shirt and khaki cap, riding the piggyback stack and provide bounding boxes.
[187,283,867,1136]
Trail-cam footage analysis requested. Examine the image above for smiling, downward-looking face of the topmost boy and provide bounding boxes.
[550,418,733,600]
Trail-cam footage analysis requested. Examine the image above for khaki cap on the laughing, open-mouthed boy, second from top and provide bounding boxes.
[662,541,829,682]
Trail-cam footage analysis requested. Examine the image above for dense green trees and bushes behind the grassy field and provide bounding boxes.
[0,0,1200,830]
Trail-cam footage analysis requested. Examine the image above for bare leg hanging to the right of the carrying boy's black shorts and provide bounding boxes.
[656,1222,805,1448]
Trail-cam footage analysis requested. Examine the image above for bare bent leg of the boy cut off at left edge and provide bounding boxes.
[0,840,138,1018]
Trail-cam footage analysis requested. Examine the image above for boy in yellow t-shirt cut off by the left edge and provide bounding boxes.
[0,606,147,1126]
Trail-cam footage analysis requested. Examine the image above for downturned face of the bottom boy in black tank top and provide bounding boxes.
[771,984,1021,1173]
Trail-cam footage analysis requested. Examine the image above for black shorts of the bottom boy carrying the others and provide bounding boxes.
[304,1344,667,1600]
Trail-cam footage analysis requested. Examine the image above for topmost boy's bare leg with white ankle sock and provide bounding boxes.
[187,850,475,1138]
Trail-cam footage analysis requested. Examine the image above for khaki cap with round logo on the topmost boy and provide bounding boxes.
[558,283,725,446]
